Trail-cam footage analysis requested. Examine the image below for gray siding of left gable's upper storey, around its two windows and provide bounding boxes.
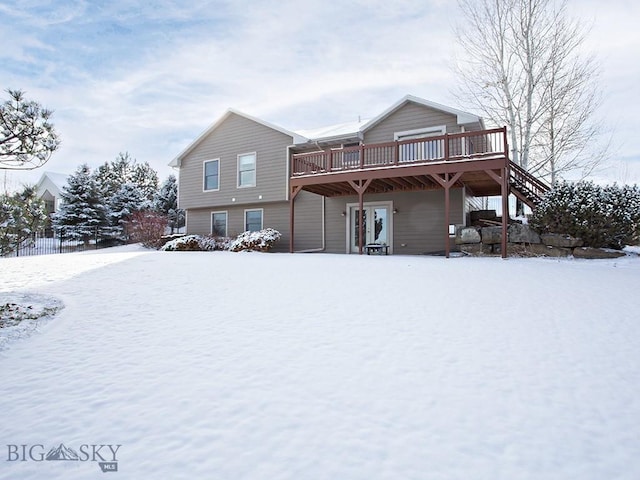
[178,113,293,210]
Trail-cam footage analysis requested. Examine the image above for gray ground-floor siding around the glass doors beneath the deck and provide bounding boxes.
[326,188,464,255]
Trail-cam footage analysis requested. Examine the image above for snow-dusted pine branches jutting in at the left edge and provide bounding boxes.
[0,90,60,170]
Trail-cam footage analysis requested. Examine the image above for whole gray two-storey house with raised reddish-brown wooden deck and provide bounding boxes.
[170,95,536,255]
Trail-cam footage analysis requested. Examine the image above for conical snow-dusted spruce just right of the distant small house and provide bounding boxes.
[53,164,108,243]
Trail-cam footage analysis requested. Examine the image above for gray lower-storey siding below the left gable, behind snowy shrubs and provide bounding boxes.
[187,192,323,252]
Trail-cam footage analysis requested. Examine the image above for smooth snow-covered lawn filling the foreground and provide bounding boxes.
[0,246,640,480]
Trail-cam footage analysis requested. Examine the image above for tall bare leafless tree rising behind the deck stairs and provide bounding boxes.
[456,0,608,183]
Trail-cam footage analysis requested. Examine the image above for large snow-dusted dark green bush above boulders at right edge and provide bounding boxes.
[530,181,640,249]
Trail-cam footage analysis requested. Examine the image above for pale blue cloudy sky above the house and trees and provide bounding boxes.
[0,0,640,188]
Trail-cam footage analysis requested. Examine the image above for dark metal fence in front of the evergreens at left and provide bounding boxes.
[3,227,127,257]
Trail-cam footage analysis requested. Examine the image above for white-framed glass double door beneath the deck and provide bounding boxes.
[349,204,392,253]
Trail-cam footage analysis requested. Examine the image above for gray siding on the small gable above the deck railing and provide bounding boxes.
[364,102,461,144]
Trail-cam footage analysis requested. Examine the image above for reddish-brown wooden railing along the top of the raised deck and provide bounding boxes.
[291,128,508,176]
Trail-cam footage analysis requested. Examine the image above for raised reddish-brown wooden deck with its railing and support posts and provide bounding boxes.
[289,128,510,258]
